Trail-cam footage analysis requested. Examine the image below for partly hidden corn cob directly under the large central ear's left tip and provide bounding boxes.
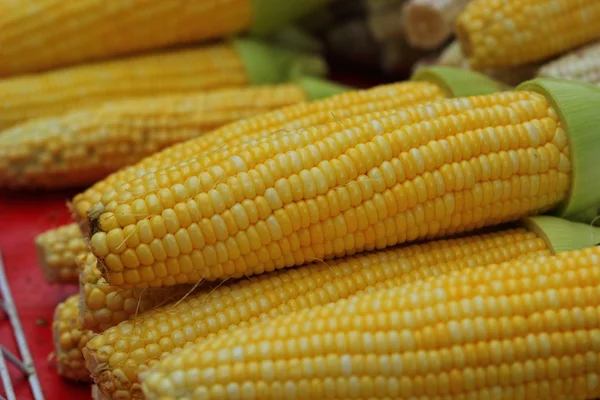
[79,253,190,332]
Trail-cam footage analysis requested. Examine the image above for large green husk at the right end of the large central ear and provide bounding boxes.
[517,78,600,218]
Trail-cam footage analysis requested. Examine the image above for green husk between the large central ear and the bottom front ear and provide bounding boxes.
[521,215,600,254]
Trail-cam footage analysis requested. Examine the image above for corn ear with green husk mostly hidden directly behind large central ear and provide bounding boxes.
[73,68,501,230]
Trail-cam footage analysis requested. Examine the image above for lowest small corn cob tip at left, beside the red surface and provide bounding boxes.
[52,295,93,382]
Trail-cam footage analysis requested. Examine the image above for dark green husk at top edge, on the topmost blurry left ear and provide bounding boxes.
[250,0,330,36]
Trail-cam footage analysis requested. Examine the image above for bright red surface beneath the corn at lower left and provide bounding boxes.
[0,191,91,400]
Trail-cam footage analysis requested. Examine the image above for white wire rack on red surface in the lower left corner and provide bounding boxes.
[0,253,44,400]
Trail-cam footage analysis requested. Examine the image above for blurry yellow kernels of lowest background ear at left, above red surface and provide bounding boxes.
[0,84,307,188]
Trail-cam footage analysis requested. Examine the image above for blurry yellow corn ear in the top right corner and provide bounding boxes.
[456,0,600,69]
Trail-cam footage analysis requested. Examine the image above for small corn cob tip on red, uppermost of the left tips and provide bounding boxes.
[35,223,88,283]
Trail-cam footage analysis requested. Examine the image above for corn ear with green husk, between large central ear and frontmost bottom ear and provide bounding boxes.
[84,217,590,399]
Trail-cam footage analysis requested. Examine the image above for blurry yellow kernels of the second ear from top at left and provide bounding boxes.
[0,43,250,129]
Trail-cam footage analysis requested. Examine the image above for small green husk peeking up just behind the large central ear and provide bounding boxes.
[411,66,511,97]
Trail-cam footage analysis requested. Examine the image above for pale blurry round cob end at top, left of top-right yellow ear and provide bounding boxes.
[402,0,470,50]
